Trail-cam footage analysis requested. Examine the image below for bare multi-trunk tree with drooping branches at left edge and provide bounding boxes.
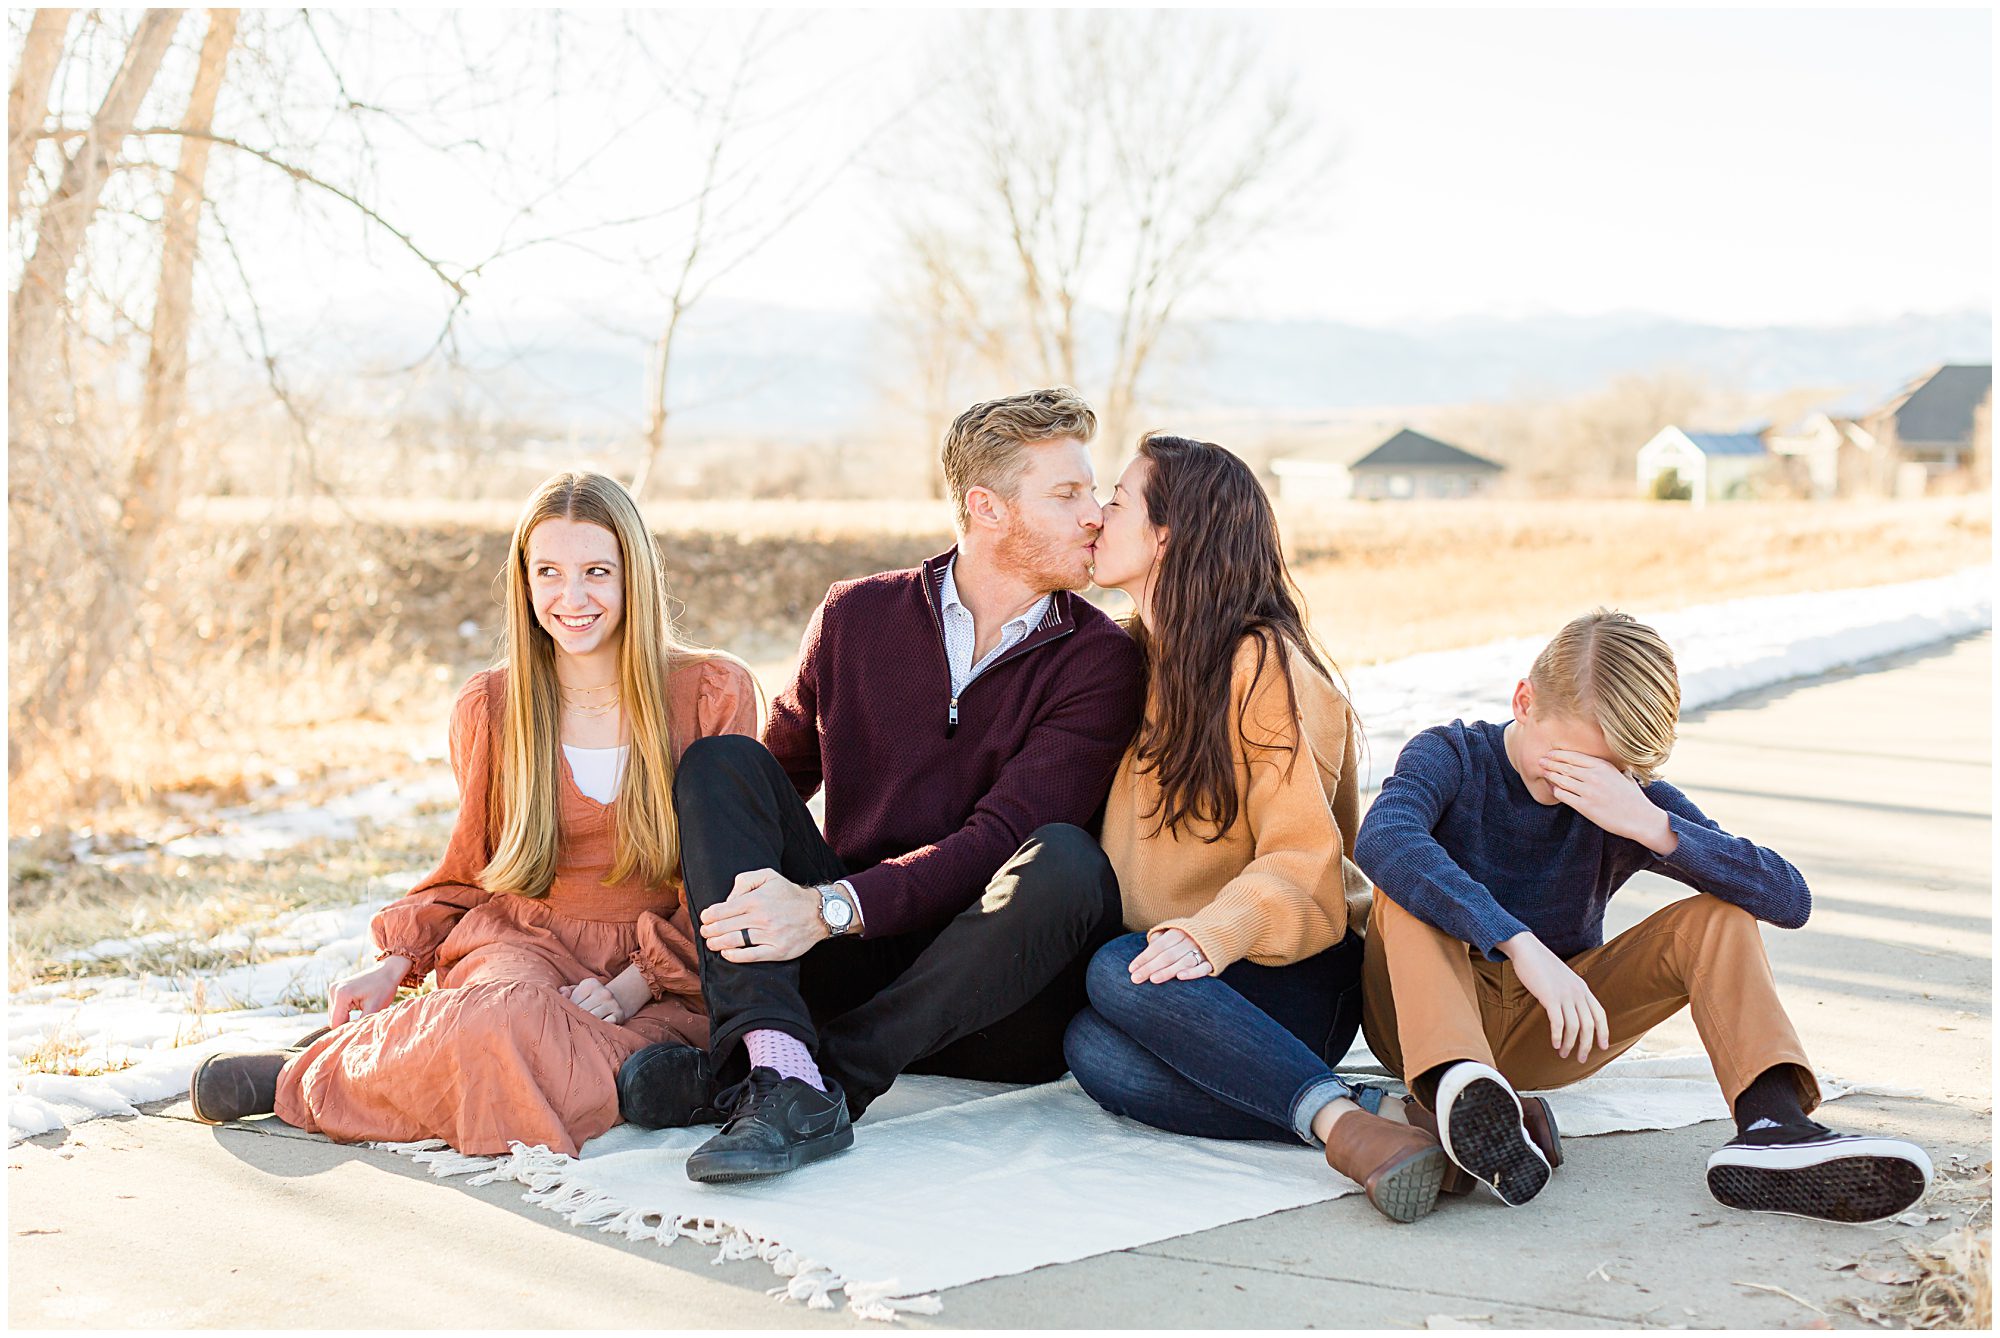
[8,10,496,774]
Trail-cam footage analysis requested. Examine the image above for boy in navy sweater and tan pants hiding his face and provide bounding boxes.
[1354,610,1930,1222]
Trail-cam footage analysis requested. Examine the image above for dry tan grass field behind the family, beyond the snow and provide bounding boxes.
[10,498,1992,836]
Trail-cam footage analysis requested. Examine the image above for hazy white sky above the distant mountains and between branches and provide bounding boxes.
[58,10,1992,340]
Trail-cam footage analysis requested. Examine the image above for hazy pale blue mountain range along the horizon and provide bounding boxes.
[296,302,1992,436]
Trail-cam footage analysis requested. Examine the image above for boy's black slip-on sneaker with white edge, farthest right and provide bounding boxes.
[1708,1120,1930,1222]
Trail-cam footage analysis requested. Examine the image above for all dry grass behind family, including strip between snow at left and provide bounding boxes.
[8,498,1992,984]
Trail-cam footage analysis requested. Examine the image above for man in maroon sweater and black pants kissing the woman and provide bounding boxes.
[620,388,1142,1180]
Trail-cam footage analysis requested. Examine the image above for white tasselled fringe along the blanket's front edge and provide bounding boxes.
[374,1138,944,1322]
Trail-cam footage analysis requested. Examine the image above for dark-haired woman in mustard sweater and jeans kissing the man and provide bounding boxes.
[1064,434,1446,1222]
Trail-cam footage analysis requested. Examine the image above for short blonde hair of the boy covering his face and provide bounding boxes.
[1528,608,1680,786]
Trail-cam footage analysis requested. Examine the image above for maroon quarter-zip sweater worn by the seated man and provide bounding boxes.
[764,548,1144,938]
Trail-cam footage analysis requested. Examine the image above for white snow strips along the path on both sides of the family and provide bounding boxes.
[8,568,1992,1142]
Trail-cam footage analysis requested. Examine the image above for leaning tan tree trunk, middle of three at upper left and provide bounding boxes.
[8,10,182,430]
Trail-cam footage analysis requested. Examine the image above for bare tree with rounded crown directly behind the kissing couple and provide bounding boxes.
[884,12,1324,464]
